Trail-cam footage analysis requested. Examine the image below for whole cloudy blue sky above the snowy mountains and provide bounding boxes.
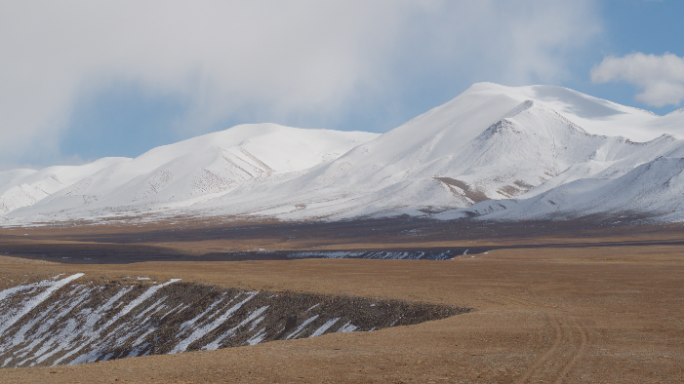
[0,0,684,168]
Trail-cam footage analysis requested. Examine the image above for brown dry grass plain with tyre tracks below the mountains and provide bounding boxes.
[0,219,684,383]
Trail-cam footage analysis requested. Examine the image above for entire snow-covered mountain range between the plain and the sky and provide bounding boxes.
[0,83,684,224]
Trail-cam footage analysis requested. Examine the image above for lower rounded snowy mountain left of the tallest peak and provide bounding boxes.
[2,124,377,217]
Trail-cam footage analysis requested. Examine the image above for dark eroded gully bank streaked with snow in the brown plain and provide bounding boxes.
[0,276,472,367]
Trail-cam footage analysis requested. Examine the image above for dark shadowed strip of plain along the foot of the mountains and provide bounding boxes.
[0,216,684,264]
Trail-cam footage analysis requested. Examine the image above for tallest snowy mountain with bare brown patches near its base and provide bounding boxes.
[191,84,681,219]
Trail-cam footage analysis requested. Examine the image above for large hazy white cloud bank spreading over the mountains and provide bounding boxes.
[0,0,600,165]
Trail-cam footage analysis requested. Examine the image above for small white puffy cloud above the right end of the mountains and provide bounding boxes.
[591,53,684,107]
